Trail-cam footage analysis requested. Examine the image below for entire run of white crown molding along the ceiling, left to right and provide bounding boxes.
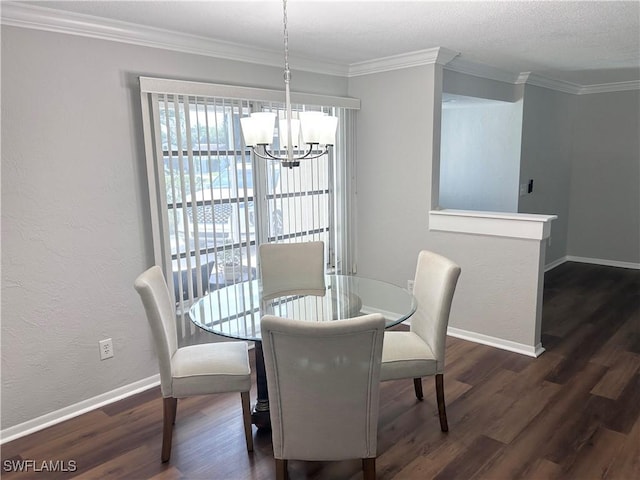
[0,2,640,95]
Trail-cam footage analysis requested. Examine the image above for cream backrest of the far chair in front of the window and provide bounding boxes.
[259,241,326,300]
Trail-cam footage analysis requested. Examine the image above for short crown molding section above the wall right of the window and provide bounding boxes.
[348,47,460,77]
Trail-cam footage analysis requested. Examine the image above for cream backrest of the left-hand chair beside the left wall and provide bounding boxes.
[134,265,178,397]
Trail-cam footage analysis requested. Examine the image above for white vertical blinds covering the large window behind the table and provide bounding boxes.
[140,77,358,339]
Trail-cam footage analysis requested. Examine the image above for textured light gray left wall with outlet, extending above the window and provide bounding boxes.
[1,26,347,429]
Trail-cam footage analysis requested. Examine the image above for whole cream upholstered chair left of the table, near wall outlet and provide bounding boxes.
[134,266,253,462]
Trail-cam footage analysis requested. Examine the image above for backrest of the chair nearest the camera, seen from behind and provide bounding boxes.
[261,314,385,460]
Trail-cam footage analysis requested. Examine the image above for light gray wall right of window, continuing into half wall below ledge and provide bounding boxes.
[349,65,544,353]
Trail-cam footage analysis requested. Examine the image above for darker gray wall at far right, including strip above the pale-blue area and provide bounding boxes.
[443,70,640,266]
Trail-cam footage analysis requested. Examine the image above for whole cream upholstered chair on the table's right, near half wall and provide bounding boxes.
[381,250,460,432]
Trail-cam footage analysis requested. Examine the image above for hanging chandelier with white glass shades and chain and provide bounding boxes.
[240,0,338,168]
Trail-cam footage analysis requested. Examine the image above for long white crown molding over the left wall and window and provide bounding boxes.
[0,3,348,77]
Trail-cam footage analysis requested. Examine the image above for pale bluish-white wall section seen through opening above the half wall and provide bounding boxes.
[439,96,522,212]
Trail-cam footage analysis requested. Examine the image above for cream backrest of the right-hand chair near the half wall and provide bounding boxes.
[411,250,460,373]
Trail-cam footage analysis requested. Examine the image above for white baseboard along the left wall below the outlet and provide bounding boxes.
[0,374,160,445]
